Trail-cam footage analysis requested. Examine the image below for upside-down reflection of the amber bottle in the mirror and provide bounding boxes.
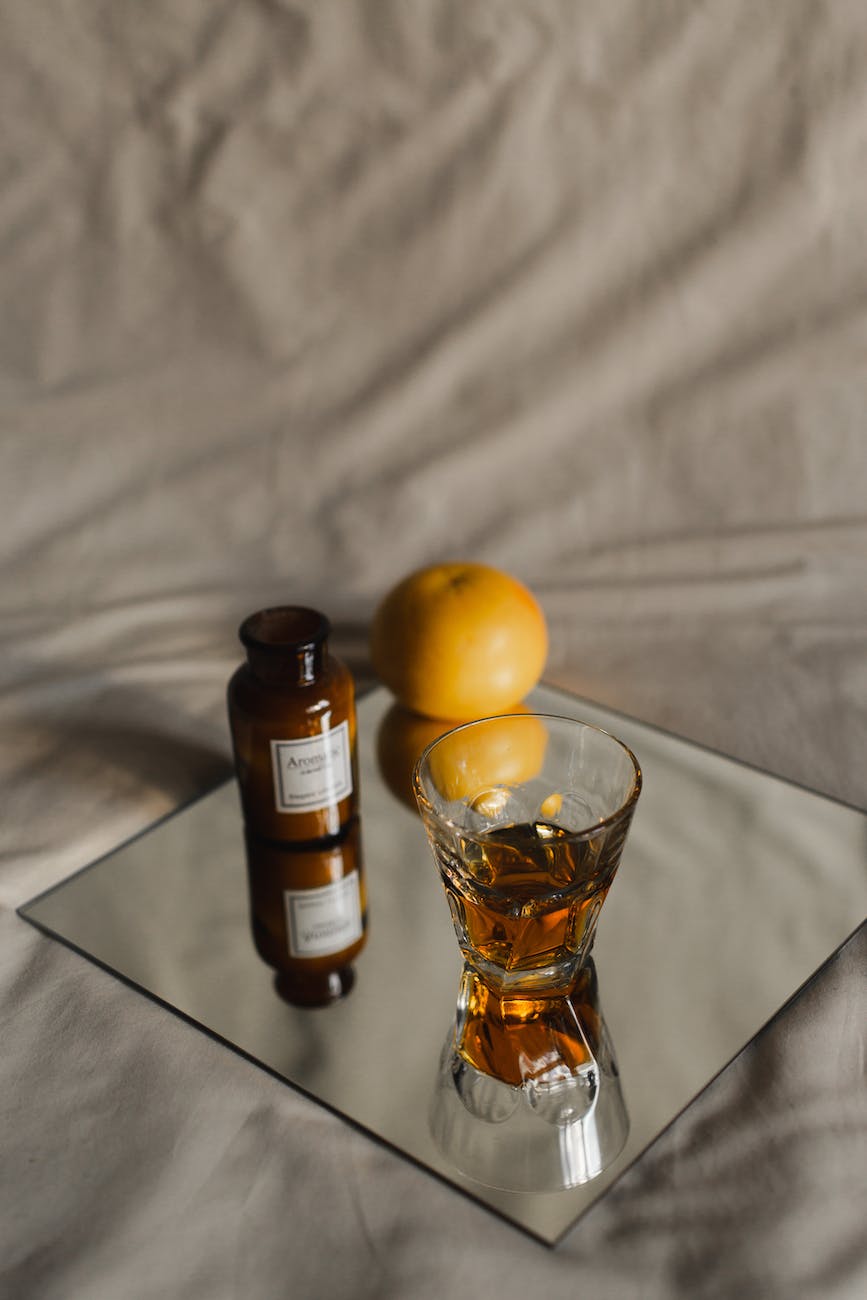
[244,818,368,1006]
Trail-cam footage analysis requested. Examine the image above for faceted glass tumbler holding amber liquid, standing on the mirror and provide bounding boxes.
[413,712,641,996]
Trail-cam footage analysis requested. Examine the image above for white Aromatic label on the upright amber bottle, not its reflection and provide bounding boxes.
[270,722,352,813]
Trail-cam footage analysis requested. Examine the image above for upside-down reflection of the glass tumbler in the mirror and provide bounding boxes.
[430,959,629,1191]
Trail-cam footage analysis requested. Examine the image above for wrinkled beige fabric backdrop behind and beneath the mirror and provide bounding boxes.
[0,0,867,1300]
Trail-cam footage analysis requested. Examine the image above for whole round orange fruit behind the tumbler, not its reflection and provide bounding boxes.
[370,562,549,722]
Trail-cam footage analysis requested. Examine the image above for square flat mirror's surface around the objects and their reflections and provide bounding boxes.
[21,686,867,1243]
